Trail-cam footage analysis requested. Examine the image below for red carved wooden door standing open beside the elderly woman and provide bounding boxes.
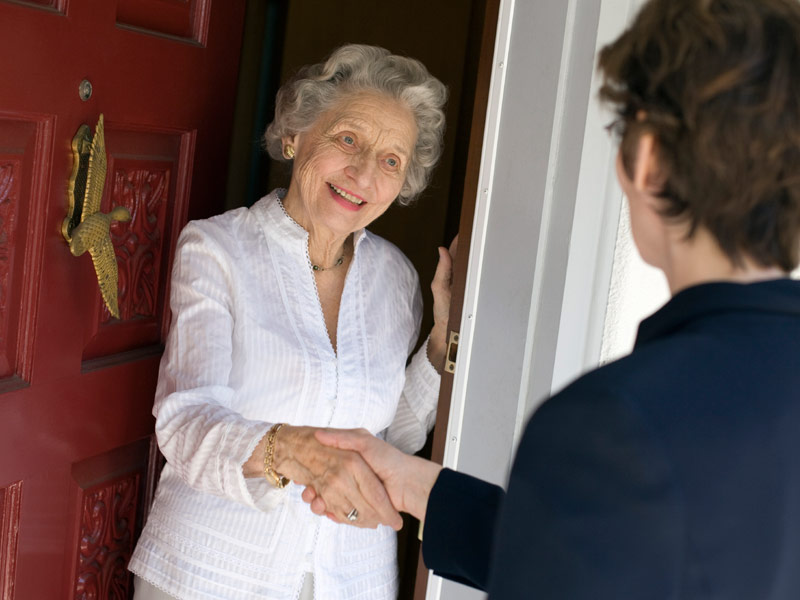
[0,0,244,600]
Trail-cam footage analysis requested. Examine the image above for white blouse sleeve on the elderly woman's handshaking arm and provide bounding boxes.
[153,223,284,510]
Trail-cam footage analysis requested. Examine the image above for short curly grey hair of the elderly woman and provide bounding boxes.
[264,44,447,205]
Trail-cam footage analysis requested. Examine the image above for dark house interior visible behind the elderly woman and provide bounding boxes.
[220,0,486,598]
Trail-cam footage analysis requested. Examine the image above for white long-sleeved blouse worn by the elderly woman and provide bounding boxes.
[129,190,439,600]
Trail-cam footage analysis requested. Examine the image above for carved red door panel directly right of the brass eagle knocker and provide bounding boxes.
[83,123,195,370]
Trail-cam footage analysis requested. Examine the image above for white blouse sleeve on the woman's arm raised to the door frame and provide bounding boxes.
[386,273,441,454]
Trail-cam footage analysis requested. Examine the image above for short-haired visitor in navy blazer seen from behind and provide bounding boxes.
[305,0,800,600]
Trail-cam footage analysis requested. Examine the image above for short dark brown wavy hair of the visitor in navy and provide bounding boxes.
[599,0,800,272]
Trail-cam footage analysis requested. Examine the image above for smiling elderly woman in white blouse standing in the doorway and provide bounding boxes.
[130,45,450,600]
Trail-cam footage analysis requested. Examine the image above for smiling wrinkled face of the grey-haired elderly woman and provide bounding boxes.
[284,92,417,238]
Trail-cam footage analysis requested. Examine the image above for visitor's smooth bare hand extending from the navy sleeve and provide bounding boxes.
[303,429,442,520]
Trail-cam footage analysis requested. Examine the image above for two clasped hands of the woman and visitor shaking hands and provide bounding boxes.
[274,426,442,530]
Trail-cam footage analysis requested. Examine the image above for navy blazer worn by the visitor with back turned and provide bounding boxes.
[423,279,800,600]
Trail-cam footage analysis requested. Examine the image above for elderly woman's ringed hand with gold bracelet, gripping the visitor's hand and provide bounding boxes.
[245,425,403,530]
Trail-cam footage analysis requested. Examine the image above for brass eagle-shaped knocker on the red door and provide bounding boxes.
[61,114,131,319]
